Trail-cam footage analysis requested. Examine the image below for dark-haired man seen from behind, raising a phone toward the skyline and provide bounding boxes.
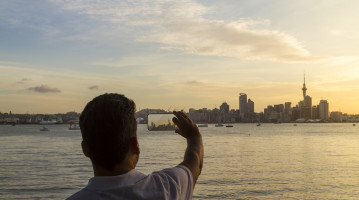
[68,94,203,200]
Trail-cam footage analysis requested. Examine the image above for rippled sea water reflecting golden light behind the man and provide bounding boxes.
[0,124,359,199]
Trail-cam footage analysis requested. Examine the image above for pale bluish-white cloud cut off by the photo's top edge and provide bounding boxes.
[50,0,209,23]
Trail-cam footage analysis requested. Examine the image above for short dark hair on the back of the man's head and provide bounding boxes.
[80,93,137,170]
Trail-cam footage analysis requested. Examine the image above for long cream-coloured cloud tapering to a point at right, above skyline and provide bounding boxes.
[142,21,320,62]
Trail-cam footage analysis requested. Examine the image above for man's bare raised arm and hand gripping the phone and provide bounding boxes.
[172,111,203,187]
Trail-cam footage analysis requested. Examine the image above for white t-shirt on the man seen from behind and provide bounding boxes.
[68,165,193,200]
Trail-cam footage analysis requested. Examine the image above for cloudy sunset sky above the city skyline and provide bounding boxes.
[0,0,359,114]
